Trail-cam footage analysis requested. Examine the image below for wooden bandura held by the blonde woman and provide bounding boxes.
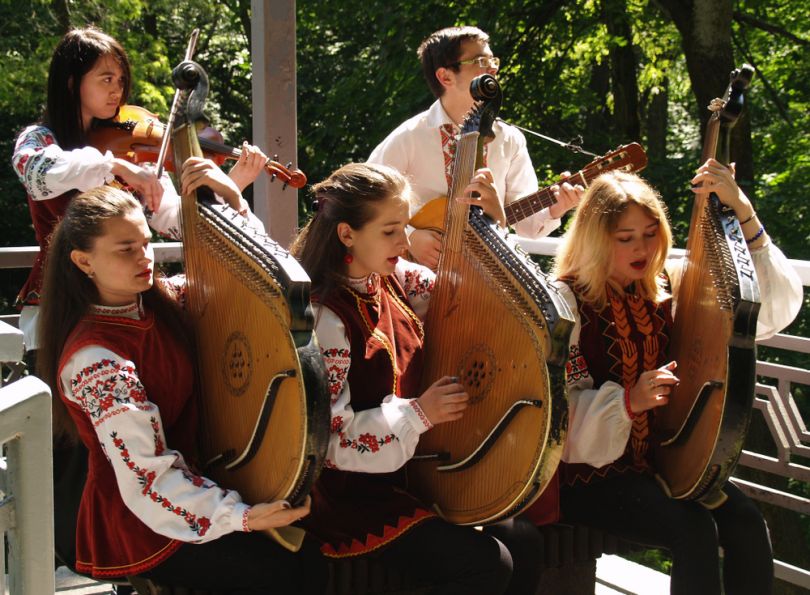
[653,64,760,508]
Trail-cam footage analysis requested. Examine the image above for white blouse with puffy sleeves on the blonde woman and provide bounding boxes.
[559,242,804,468]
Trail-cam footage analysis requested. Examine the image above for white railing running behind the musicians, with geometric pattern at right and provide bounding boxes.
[0,238,810,592]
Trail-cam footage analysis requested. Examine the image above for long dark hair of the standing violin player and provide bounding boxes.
[43,27,132,149]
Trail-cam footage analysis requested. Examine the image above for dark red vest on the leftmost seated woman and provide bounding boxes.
[59,312,197,577]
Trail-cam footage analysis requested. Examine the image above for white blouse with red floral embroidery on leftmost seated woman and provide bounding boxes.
[59,304,250,543]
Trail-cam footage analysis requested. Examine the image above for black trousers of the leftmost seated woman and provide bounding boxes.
[140,533,329,595]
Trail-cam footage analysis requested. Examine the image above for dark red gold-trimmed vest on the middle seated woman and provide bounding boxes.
[306,275,435,557]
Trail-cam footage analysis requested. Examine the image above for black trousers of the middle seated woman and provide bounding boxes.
[367,519,512,595]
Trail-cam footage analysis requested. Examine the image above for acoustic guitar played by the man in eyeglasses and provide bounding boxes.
[408,143,647,233]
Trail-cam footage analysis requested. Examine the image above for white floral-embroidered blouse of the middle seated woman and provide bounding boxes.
[314,259,436,473]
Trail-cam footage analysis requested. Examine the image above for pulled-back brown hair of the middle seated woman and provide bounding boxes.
[290,163,410,301]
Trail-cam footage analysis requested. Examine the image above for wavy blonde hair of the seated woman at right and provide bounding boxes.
[554,171,672,310]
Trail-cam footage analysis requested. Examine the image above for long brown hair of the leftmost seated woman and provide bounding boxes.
[37,186,187,442]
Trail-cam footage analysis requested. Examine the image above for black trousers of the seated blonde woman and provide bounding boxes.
[562,474,773,595]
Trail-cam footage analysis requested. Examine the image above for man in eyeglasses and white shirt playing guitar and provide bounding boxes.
[368,27,579,269]
